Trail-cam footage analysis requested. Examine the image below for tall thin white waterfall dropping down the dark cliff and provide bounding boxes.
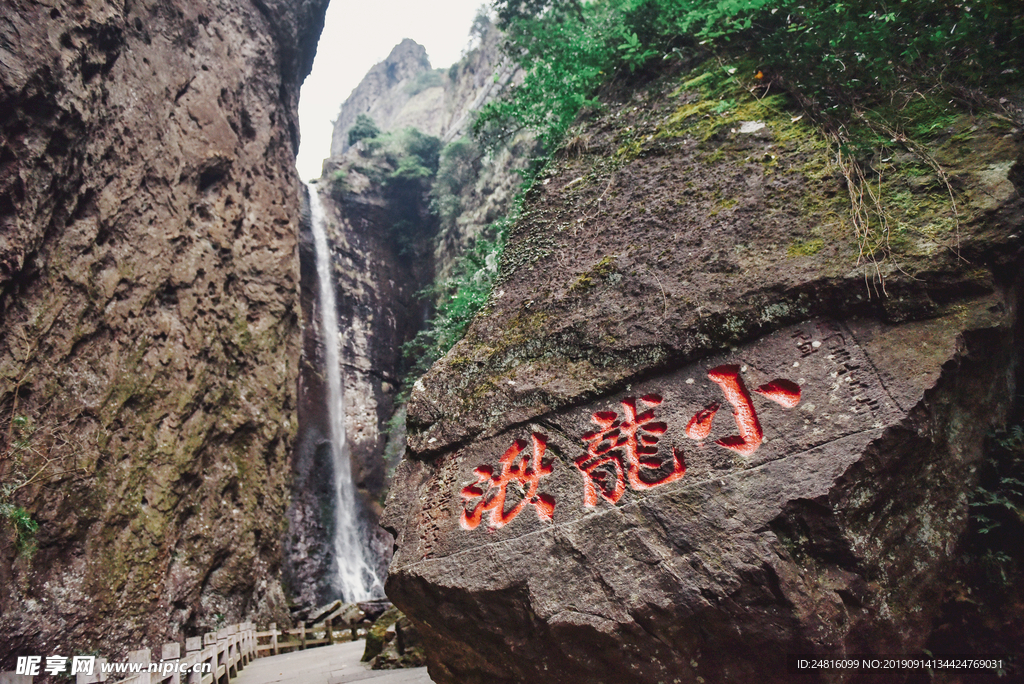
[306,183,384,602]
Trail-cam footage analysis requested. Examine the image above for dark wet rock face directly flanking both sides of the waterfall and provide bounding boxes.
[285,174,431,605]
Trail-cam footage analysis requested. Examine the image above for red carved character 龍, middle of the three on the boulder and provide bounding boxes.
[574,394,686,506]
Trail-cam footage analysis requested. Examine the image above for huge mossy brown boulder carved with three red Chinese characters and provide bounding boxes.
[382,62,1024,684]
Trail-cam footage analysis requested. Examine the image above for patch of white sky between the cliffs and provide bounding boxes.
[296,0,489,180]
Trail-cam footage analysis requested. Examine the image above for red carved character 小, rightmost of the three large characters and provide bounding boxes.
[686,366,800,456]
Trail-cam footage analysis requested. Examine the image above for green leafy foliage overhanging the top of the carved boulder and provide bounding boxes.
[475,0,1024,151]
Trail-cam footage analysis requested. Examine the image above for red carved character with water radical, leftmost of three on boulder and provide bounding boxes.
[460,432,555,529]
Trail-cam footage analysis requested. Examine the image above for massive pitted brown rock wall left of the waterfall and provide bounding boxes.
[0,0,327,671]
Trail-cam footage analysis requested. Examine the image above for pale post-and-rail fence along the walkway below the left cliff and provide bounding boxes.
[0,618,344,684]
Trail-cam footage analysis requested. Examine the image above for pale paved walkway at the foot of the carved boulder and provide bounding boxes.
[231,641,432,684]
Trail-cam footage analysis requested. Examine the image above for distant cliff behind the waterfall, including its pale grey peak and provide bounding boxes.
[286,29,531,607]
